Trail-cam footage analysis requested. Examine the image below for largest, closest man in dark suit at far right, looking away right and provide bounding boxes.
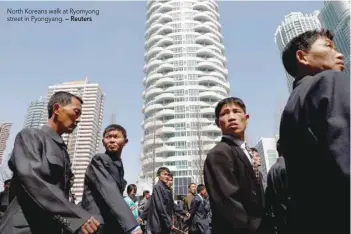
[280,30,350,234]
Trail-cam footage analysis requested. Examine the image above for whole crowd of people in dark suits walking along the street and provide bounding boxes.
[0,27,350,234]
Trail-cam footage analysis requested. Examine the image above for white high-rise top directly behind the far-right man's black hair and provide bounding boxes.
[274,11,321,93]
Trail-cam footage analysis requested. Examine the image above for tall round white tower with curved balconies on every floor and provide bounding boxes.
[141,0,230,195]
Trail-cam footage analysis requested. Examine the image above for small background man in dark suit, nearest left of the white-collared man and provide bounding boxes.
[189,184,211,234]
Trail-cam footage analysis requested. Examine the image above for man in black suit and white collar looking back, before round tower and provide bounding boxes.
[204,97,263,234]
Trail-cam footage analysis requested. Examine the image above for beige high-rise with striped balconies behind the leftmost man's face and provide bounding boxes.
[42,79,105,201]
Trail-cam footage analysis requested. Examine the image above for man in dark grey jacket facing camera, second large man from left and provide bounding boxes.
[82,124,142,234]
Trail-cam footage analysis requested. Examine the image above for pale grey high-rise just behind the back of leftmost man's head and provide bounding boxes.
[23,97,47,128]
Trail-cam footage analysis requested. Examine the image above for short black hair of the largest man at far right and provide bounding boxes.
[282,29,333,78]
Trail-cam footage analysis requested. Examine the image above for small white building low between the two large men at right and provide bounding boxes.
[255,138,278,187]
